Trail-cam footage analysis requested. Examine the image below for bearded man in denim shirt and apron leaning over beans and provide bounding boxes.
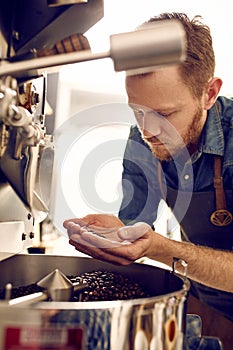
[64,13,233,346]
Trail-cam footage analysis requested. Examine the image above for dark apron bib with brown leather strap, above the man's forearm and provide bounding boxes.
[165,157,233,251]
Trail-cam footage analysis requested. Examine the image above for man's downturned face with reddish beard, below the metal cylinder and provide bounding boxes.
[126,67,207,160]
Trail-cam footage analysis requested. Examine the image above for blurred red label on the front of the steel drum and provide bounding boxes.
[4,326,84,350]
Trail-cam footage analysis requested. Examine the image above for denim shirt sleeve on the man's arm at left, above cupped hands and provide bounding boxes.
[119,126,161,226]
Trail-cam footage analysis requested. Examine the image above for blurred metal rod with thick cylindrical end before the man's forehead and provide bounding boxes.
[0,20,186,76]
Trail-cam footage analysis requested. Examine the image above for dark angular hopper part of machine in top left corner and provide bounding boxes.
[0,0,103,60]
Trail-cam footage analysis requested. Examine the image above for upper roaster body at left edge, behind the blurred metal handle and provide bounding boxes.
[0,0,103,257]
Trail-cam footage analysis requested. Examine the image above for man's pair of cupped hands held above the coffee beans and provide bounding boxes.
[64,214,154,265]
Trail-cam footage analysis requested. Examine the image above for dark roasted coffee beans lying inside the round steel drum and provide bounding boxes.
[0,271,149,302]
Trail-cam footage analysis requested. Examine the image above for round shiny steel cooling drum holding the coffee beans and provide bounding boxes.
[0,255,189,350]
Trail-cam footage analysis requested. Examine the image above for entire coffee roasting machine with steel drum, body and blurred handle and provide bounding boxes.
[0,0,208,350]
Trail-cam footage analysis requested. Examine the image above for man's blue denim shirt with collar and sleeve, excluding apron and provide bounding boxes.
[119,97,233,226]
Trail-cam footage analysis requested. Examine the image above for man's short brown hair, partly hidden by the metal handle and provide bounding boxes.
[144,12,215,97]
